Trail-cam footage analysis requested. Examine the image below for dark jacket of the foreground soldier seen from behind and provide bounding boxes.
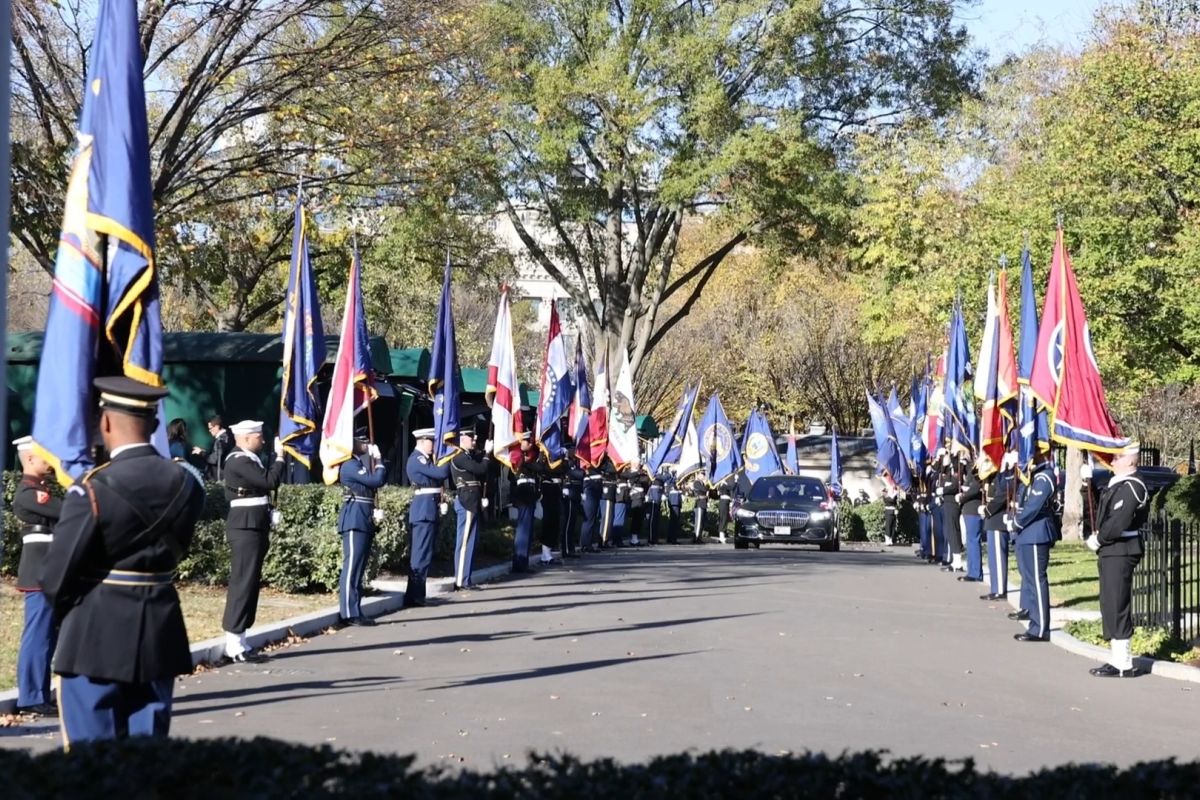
[42,444,204,684]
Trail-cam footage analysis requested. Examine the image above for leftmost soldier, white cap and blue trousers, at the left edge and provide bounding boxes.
[12,437,62,716]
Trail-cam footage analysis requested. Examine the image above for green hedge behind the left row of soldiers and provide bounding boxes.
[0,473,512,591]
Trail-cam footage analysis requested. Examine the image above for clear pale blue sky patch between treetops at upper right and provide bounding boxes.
[960,0,1111,62]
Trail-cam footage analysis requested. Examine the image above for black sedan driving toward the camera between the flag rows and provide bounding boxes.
[733,475,841,551]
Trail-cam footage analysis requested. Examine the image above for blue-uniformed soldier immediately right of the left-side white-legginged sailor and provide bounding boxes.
[337,431,388,626]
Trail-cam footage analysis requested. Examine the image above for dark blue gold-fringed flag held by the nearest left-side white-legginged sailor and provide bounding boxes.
[280,193,325,468]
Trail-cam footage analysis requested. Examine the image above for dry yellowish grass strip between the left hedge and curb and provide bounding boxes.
[0,578,337,690]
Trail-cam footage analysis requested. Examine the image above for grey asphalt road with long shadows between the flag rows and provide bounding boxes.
[0,545,1200,775]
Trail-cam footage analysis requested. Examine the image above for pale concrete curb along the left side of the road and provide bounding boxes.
[0,564,512,714]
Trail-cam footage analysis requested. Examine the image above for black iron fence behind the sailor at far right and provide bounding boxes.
[1133,511,1200,642]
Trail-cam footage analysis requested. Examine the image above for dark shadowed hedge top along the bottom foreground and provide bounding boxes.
[0,739,1200,800]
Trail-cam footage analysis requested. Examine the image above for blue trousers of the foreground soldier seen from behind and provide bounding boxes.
[59,675,175,750]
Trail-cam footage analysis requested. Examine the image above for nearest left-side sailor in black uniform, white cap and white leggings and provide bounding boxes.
[221,420,283,662]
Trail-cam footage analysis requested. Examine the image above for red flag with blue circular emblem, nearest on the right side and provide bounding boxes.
[1030,228,1128,453]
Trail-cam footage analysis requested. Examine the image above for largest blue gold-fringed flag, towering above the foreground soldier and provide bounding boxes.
[34,0,163,483]
